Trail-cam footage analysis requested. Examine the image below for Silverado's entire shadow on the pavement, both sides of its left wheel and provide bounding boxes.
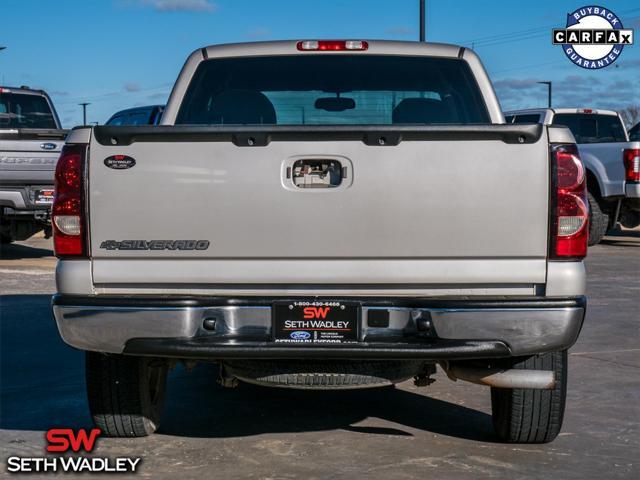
[0,295,495,442]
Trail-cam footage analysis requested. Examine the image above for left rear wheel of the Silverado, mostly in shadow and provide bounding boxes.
[85,352,168,437]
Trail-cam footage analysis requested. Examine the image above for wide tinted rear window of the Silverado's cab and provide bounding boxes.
[176,54,490,125]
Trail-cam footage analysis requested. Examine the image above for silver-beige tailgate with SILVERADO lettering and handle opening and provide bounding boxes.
[89,126,549,288]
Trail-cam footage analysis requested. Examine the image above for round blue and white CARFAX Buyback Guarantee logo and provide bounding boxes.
[553,5,633,70]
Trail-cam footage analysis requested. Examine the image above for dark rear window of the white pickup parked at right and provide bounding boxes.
[553,113,627,143]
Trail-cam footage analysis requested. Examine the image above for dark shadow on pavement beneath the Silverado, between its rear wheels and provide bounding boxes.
[159,365,496,442]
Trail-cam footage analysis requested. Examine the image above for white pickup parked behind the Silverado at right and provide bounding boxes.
[505,108,640,245]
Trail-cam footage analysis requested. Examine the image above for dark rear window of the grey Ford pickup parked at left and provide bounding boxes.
[0,93,57,128]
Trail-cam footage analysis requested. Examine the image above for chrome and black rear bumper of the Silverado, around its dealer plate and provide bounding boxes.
[53,296,586,360]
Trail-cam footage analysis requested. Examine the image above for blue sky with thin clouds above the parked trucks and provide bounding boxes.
[0,0,640,127]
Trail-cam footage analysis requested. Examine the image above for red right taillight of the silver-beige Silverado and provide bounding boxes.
[550,144,589,260]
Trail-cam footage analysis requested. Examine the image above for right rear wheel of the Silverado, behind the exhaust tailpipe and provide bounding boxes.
[491,350,567,443]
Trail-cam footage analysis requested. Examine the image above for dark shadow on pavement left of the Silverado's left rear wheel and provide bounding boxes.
[0,295,91,430]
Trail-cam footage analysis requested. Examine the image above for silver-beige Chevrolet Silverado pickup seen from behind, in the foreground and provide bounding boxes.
[53,40,588,443]
